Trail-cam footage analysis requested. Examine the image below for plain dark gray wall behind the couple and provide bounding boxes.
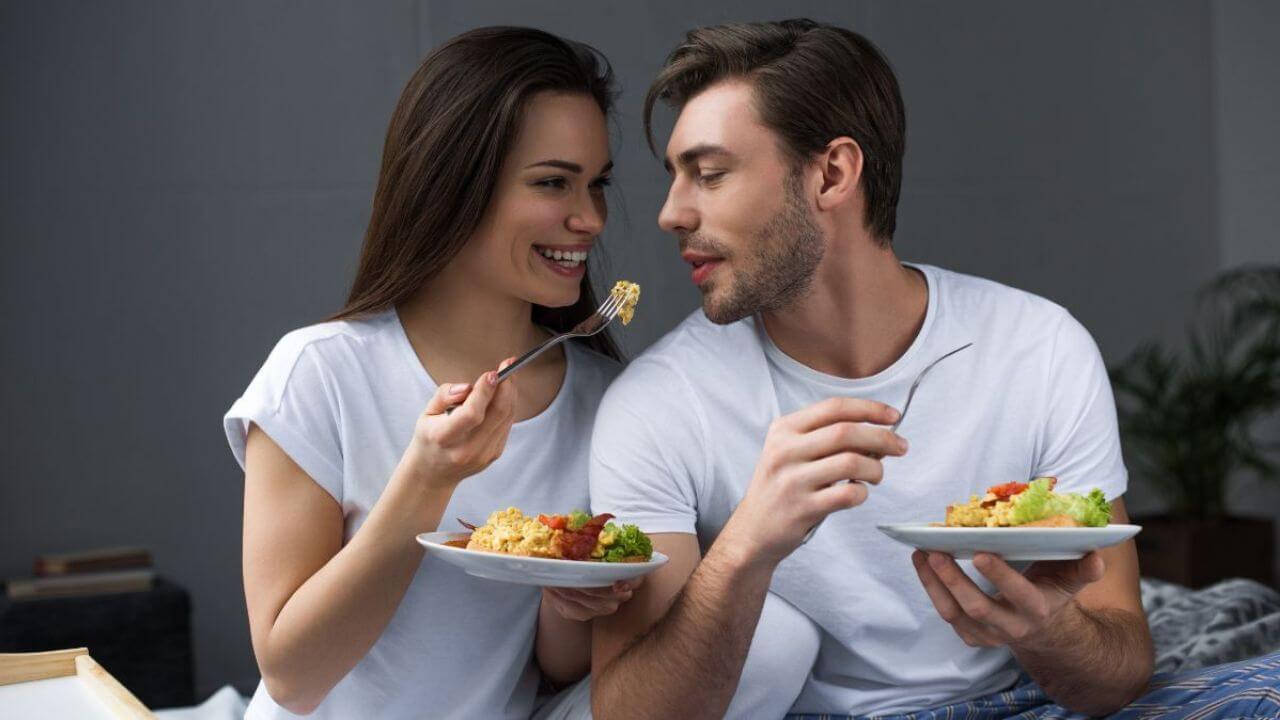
[0,0,1280,694]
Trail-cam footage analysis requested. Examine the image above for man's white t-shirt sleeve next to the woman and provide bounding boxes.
[590,359,705,534]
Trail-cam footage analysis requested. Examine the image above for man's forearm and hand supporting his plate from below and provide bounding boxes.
[914,498,1155,715]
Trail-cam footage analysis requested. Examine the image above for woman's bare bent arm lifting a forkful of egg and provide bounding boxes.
[244,373,515,714]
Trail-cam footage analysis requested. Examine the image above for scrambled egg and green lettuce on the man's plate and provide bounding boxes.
[945,478,1111,528]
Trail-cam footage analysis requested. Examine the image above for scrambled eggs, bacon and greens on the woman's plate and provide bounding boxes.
[466,507,653,562]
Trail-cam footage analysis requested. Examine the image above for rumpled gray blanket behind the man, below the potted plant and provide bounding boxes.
[1142,578,1280,673]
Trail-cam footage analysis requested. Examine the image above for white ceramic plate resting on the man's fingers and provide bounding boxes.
[877,523,1142,560]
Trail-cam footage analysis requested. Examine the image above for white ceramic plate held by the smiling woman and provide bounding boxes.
[417,533,667,588]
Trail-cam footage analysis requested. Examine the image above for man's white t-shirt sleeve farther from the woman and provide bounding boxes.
[1034,315,1129,500]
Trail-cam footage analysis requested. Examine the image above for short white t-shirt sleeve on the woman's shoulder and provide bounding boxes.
[223,333,343,503]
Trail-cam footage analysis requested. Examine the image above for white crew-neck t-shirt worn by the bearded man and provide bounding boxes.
[591,265,1128,715]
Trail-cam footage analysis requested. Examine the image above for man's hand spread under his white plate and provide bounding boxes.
[911,551,1106,648]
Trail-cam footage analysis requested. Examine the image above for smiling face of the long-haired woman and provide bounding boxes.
[456,92,613,307]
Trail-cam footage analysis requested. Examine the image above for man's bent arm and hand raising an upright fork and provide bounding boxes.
[591,398,906,720]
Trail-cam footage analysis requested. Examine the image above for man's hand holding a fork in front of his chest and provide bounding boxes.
[721,397,906,564]
